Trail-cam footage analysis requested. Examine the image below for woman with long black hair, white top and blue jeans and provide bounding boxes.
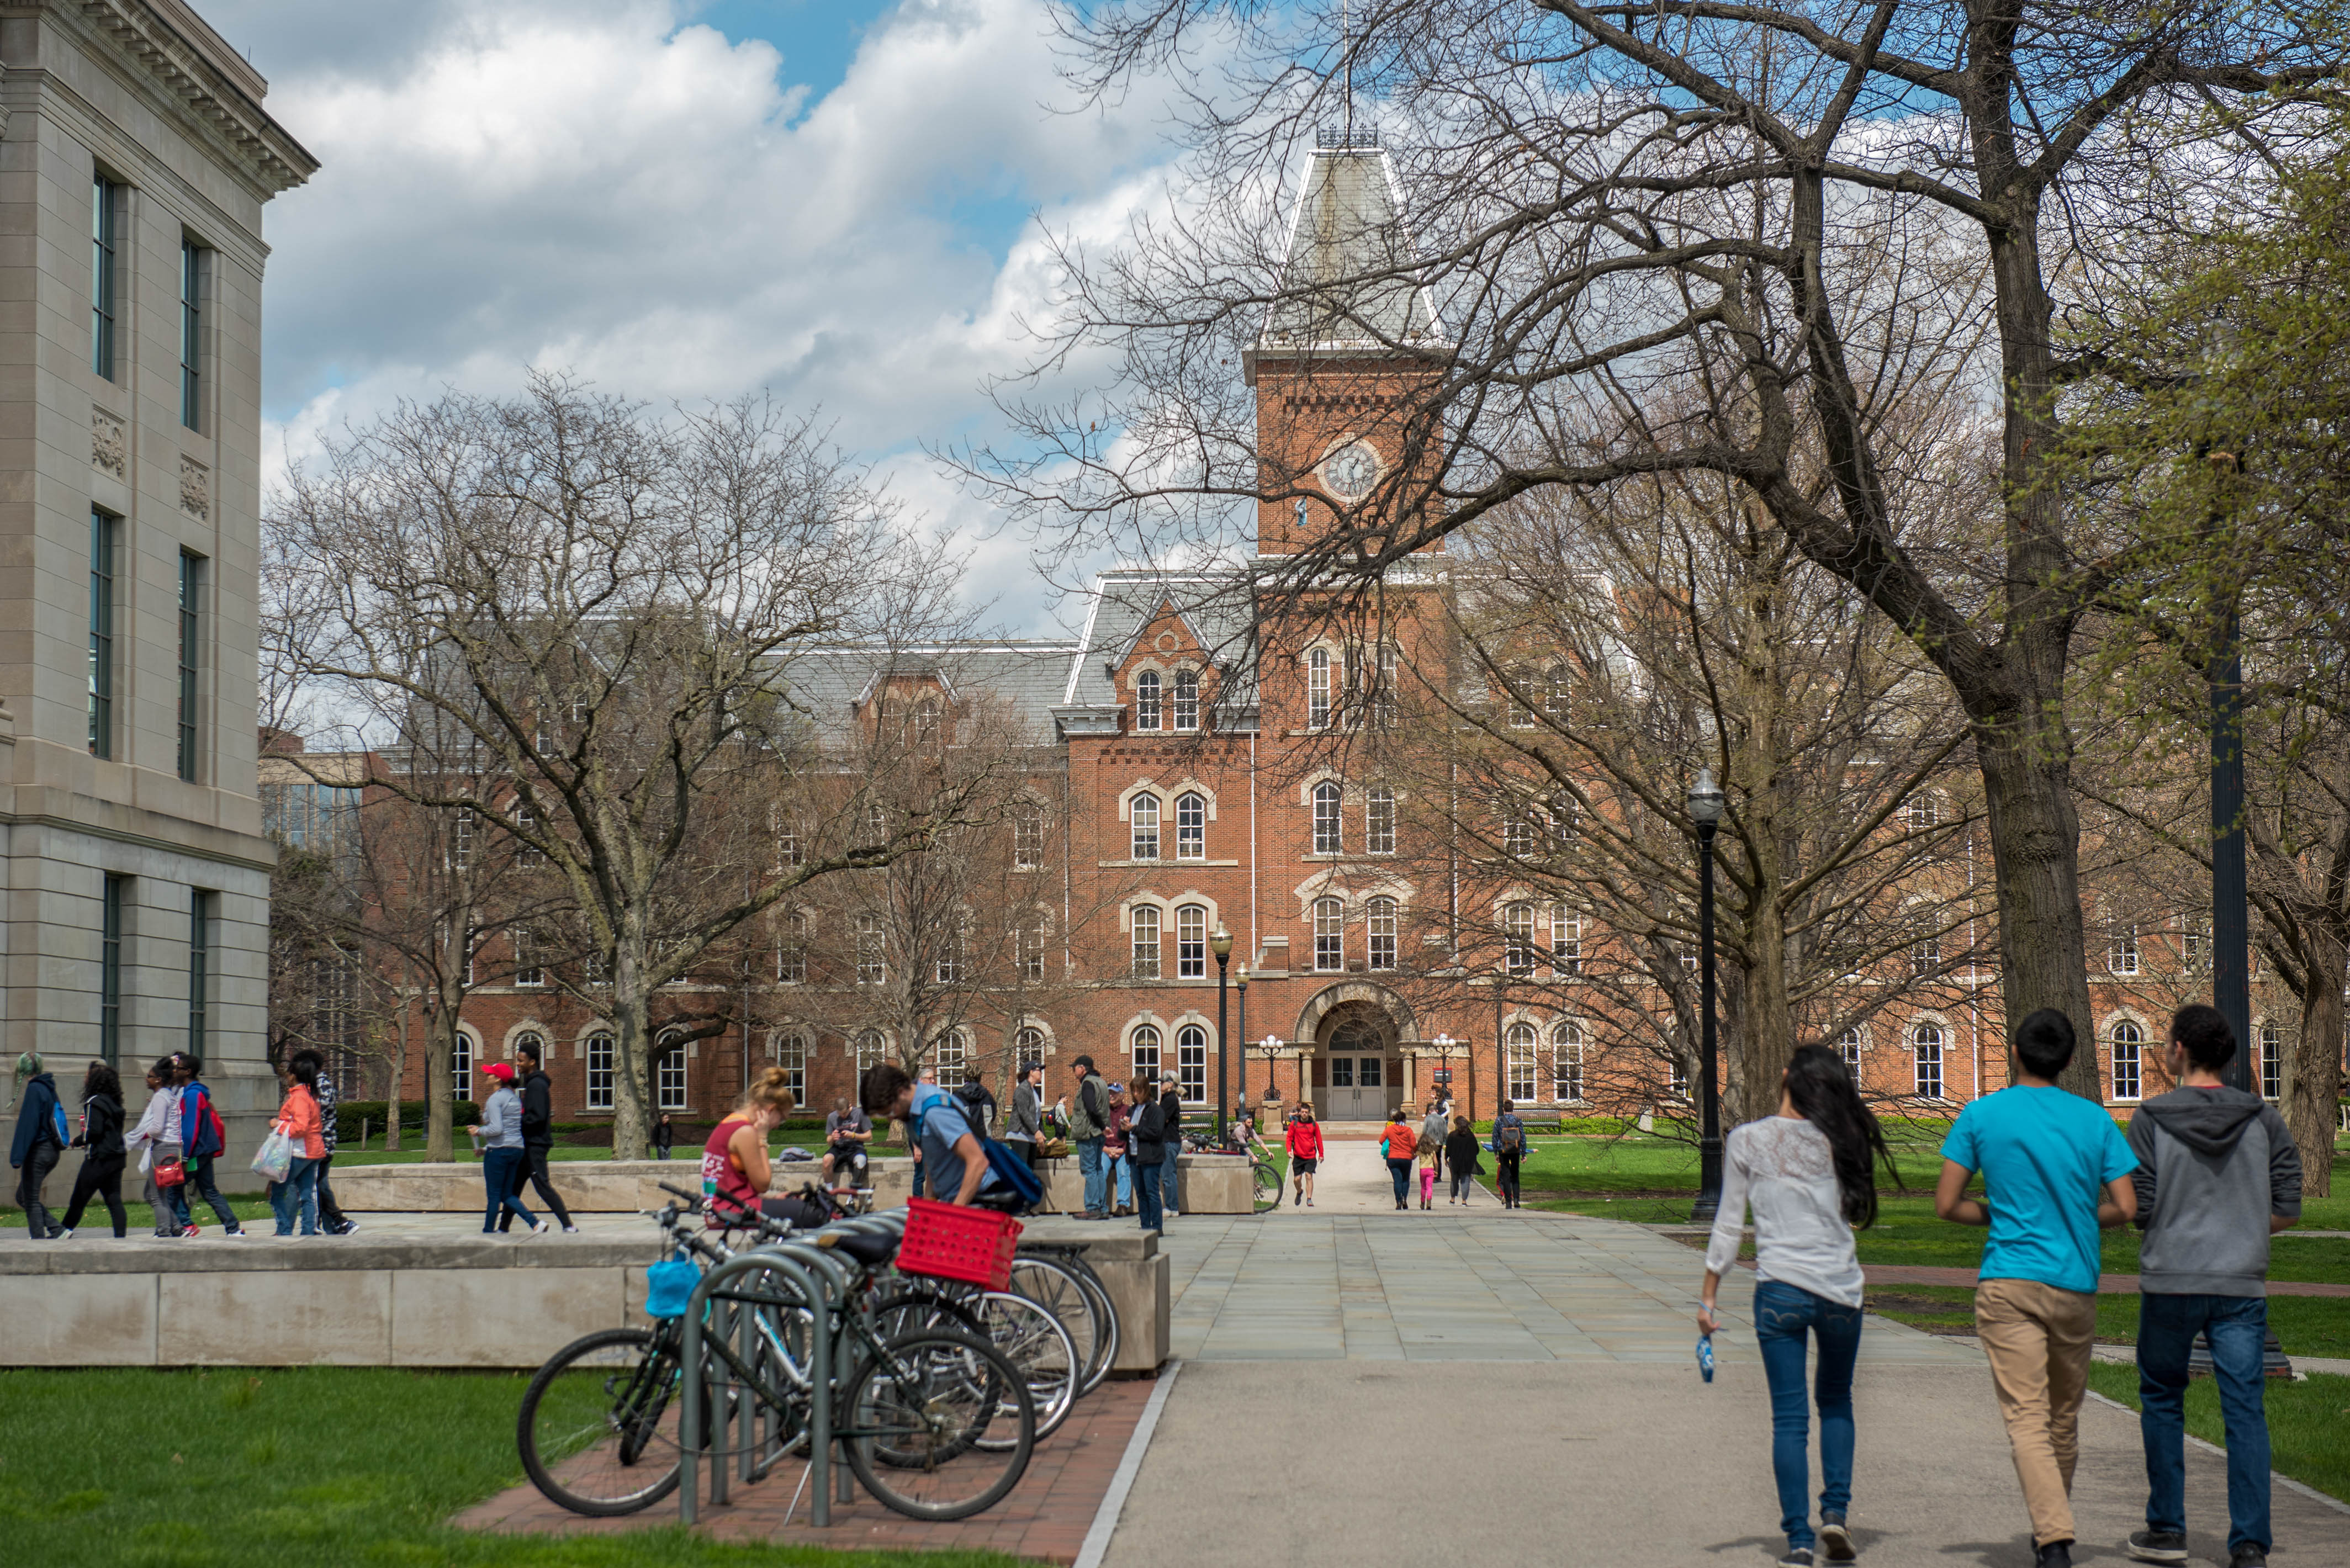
[1697,1046,1901,1568]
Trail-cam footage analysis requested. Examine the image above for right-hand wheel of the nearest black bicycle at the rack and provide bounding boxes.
[834,1333,1036,1519]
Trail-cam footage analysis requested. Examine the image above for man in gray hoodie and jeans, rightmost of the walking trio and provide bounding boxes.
[2129,1004,2301,1568]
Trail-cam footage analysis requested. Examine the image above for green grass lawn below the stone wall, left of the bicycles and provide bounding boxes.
[0,1368,1015,1568]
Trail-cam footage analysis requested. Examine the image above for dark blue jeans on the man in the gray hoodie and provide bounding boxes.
[2139,1295,2270,1554]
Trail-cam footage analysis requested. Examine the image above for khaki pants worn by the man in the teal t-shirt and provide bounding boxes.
[1974,1279,2096,1547]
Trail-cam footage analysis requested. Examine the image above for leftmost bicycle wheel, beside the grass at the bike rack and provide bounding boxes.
[515,1328,679,1519]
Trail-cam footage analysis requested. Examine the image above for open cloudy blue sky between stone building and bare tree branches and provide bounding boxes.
[195,0,1203,632]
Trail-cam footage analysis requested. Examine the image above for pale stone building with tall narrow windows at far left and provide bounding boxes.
[0,0,317,1145]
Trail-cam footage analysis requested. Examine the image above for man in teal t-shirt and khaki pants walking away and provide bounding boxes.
[1934,1009,2139,1568]
